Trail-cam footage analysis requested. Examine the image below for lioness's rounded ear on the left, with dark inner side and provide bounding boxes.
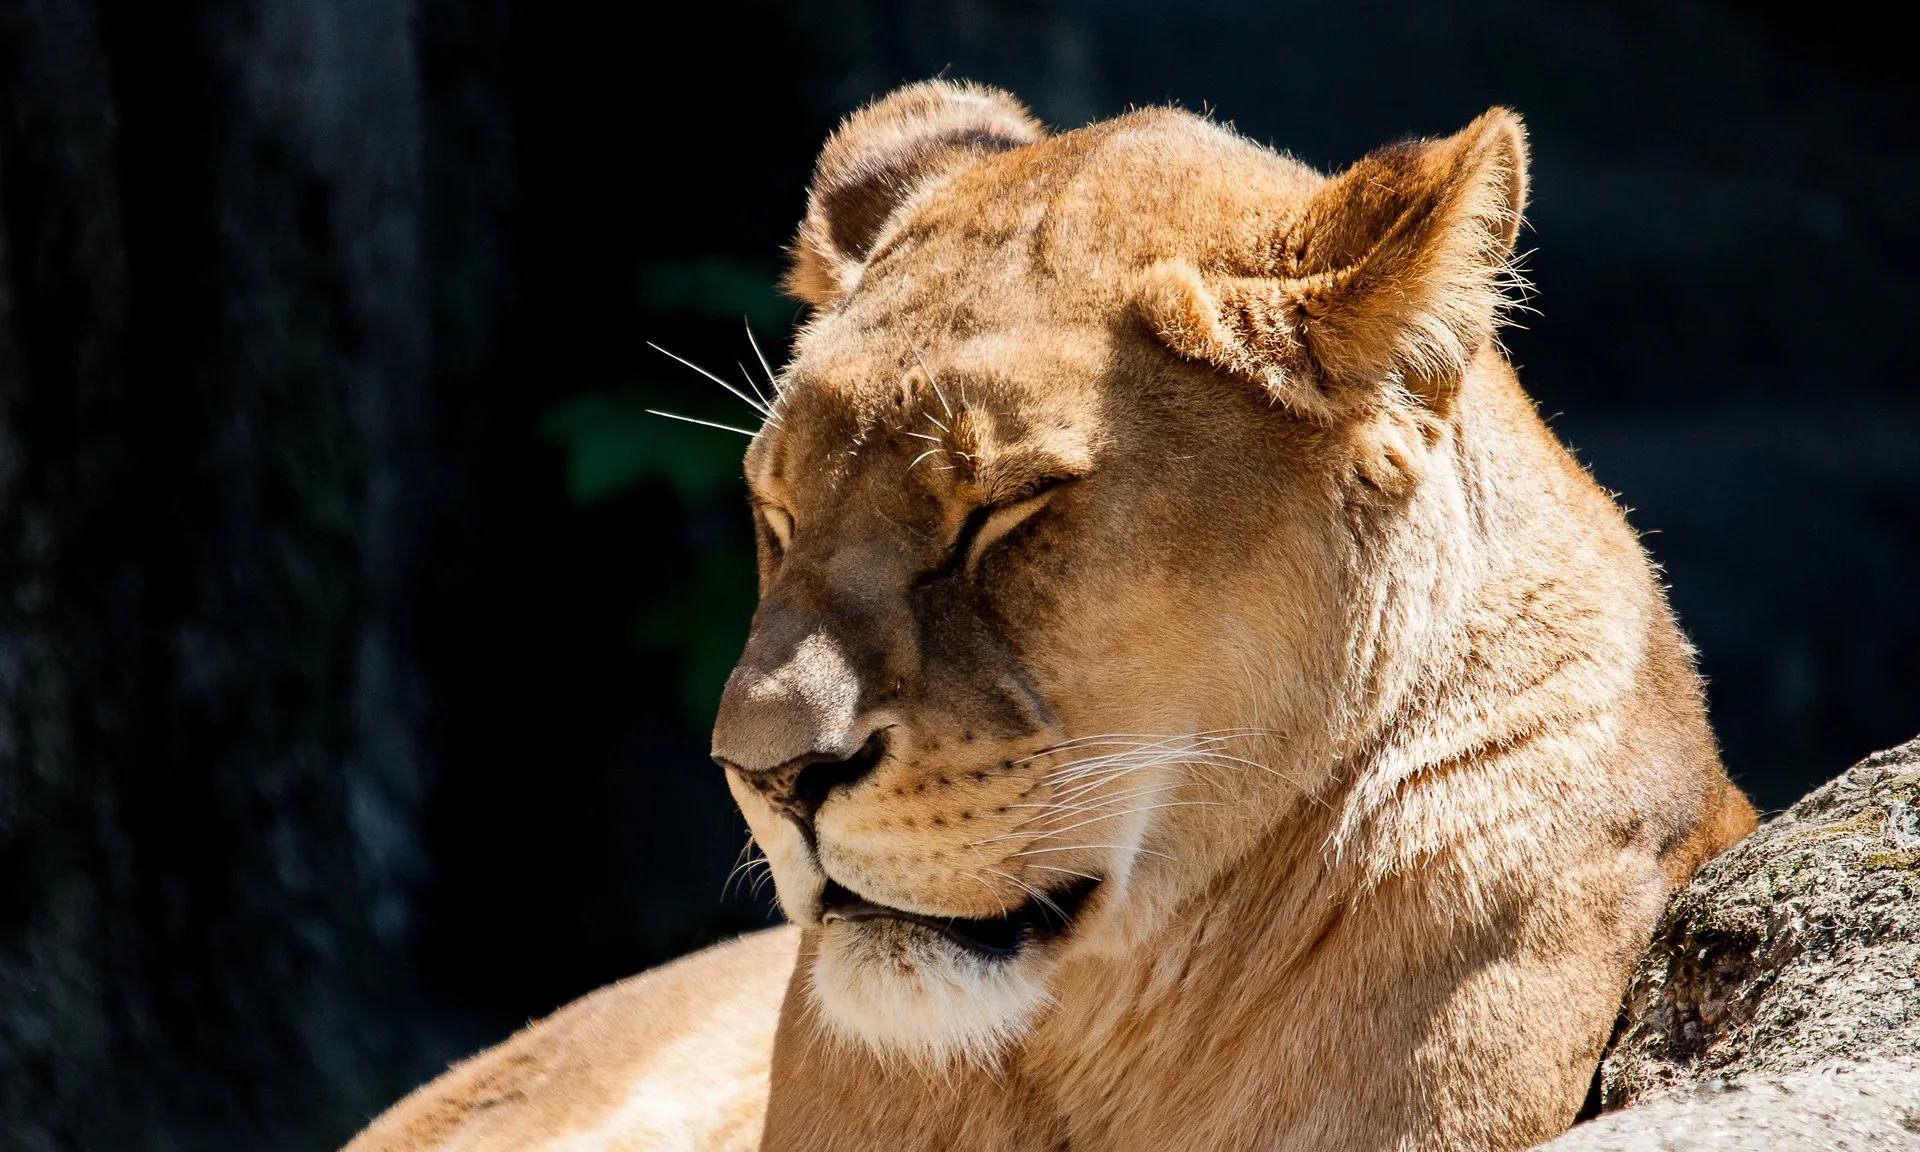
[785,81,1046,309]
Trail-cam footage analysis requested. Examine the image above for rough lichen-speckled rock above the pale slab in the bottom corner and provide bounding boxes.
[1601,739,1920,1110]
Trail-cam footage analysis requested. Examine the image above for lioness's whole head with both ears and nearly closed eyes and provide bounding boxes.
[714,84,1519,1060]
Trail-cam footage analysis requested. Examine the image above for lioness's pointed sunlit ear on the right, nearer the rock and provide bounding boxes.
[1139,108,1526,420]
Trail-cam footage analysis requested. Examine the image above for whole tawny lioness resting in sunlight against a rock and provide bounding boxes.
[353,83,1753,1152]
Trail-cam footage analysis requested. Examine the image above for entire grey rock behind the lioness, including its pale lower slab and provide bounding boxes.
[1544,739,1920,1152]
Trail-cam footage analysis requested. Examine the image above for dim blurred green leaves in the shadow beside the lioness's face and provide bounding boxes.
[540,259,793,728]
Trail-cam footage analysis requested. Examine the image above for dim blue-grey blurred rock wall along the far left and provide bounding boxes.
[0,0,503,1150]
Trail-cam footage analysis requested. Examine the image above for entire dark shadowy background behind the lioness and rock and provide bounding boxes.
[0,0,1920,1152]
